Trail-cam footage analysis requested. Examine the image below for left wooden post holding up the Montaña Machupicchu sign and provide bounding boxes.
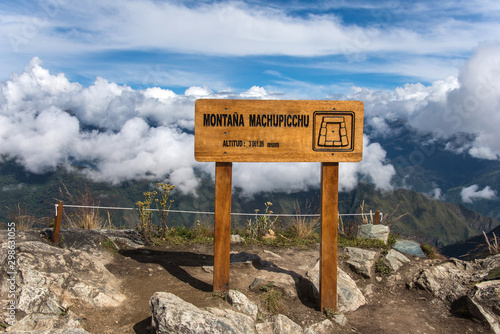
[213,162,233,292]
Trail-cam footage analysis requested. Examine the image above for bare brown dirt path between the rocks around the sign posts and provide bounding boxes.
[73,245,491,334]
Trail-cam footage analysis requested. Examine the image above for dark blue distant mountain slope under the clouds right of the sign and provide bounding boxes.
[372,122,500,220]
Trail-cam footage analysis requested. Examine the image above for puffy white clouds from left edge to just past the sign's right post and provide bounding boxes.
[0,58,395,195]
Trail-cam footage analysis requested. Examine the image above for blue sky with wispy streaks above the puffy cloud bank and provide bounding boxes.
[0,0,500,98]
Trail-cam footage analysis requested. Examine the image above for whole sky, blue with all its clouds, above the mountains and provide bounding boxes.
[0,0,500,200]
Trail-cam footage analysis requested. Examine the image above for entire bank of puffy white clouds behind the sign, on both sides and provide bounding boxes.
[0,45,500,196]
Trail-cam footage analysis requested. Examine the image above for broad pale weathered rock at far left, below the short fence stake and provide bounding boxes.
[11,241,126,314]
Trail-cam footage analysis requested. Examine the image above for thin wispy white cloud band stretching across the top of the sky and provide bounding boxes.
[0,0,500,56]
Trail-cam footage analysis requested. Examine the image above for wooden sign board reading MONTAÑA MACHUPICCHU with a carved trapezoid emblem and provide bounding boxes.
[195,99,364,162]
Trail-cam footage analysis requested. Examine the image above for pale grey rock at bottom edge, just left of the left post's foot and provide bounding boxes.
[149,292,255,334]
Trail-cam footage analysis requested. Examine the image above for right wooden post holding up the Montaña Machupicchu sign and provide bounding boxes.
[319,162,339,312]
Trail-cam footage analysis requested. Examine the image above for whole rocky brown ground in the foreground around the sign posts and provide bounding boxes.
[0,230,500,334]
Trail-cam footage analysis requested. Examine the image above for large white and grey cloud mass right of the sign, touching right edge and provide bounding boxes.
[349,44,500,160]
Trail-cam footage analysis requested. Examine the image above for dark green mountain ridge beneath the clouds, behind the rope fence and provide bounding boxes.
[0,161,500,247]
